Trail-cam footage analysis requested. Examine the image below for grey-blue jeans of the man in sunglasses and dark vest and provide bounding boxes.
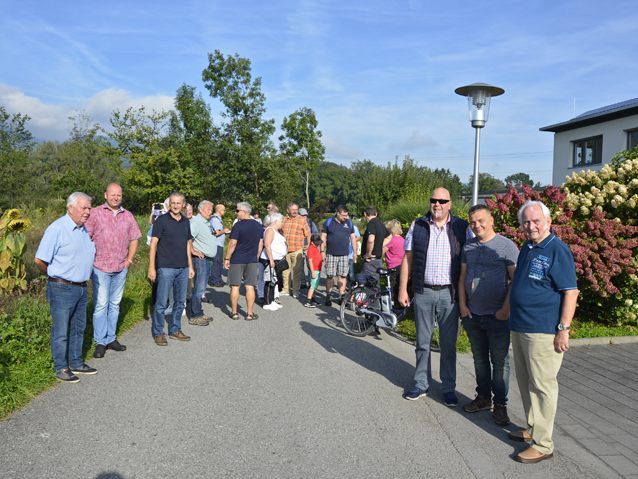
[412,288,459,394]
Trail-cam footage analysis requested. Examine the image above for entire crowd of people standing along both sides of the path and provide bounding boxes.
[35,183,579,463]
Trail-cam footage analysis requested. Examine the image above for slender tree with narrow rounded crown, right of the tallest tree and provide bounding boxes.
[279,107,326,208]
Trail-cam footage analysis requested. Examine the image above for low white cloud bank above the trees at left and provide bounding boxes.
[0,84,173,141]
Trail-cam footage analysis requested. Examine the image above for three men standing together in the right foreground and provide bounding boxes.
[399,188,579,463]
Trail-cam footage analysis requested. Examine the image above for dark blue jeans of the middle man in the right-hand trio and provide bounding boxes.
[461,314,510,406]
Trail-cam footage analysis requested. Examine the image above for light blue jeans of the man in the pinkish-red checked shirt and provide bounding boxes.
[91,267,128,346]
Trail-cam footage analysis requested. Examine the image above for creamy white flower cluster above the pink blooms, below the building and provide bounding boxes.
[563,158,638,221]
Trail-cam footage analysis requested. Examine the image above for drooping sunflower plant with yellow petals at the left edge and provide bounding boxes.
[0,209,31,295]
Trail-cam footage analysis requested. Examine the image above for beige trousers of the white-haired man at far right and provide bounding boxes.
[512,331,563,454]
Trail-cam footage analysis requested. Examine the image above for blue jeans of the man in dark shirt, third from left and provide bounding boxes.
[151,268,188,336]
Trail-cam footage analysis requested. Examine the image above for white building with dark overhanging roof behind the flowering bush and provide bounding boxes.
[540,98,638,185]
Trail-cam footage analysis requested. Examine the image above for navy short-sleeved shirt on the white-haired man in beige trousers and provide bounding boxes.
[510,234,578,334]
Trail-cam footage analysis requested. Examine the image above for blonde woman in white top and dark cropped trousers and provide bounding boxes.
[259,213,288,311]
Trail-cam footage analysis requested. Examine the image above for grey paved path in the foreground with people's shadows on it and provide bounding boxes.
[0,286,638,479]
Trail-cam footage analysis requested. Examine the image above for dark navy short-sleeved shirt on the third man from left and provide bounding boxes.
[153,212,192,268]
